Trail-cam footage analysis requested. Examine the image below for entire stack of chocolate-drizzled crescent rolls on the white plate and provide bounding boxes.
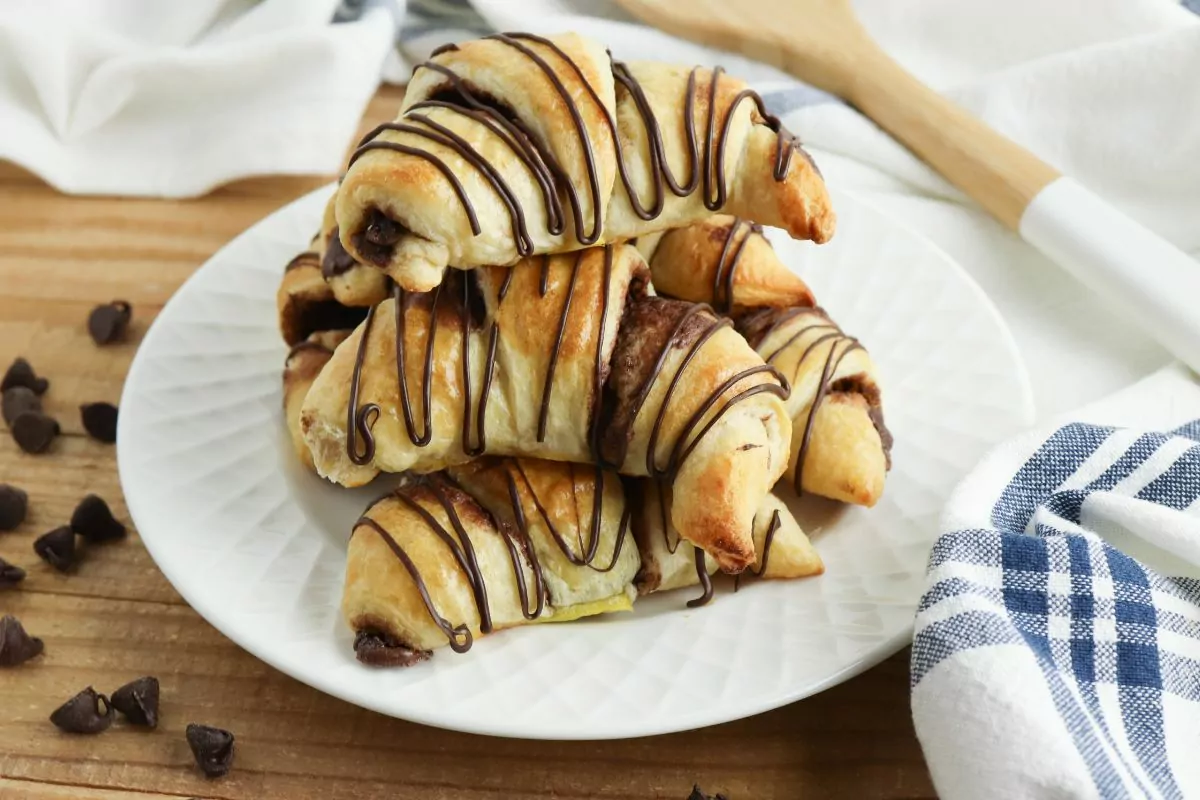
[278,34,890,666]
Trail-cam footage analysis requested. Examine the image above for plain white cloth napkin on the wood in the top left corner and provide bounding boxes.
[0,0,395,197]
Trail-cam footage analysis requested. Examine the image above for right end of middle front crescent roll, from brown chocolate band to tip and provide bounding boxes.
[604,297,791,572]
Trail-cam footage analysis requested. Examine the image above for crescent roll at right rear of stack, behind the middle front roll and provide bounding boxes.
[637,216,892,506]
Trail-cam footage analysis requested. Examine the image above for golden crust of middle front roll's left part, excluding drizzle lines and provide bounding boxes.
[302,246,646,486]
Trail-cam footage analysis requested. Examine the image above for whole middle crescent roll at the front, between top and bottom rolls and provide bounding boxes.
[301,245,791,572]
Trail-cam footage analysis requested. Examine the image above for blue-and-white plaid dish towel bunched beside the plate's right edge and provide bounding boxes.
[912,367,1200,798]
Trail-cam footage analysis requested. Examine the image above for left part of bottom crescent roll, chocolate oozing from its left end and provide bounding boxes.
[342,459,638,666]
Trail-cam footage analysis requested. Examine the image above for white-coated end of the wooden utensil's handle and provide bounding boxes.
[1019,176,1200,372]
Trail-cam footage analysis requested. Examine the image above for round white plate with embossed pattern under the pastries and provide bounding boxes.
[118,184,1032,739]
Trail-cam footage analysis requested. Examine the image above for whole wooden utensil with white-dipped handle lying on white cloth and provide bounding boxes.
[618,0,1200,371]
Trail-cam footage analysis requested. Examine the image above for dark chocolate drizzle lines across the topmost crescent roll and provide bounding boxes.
[349,32,803,258]
